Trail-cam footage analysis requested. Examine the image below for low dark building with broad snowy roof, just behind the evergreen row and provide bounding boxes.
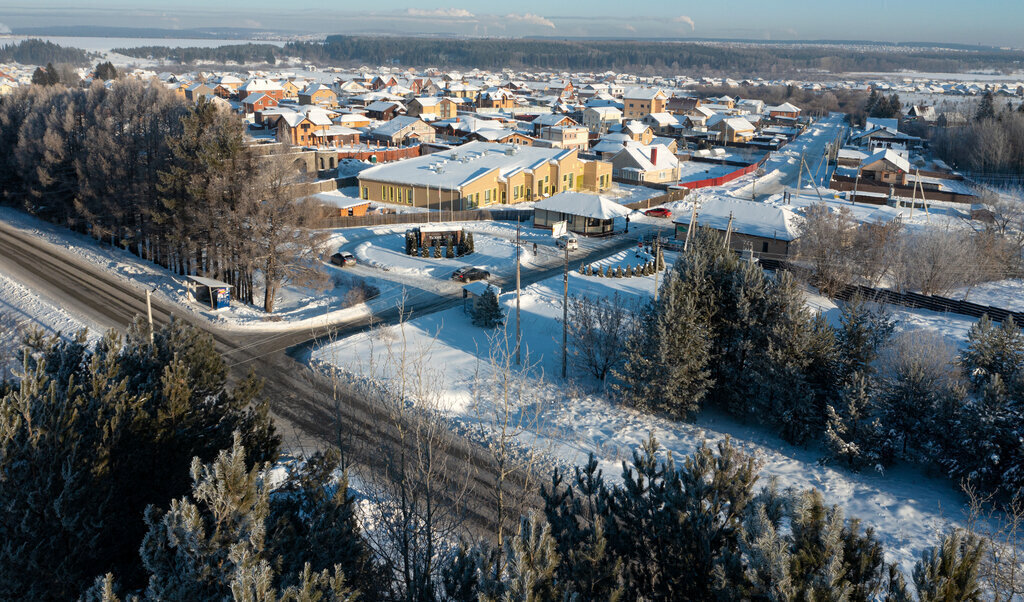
[673,197,800,259]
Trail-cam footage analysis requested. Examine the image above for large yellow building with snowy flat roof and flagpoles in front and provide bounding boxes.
[359,142,611,209]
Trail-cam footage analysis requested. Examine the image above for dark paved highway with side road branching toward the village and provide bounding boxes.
[0,217,671,532]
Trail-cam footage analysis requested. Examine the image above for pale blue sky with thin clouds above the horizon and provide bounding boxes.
[0,0,1024,48]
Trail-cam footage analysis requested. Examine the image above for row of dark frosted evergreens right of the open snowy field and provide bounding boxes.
[614,225,1024,499]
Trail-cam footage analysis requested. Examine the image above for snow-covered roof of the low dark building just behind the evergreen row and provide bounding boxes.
[673,197,800,241]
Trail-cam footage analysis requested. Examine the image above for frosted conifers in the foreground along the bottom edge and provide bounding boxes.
[0,327,1019,602]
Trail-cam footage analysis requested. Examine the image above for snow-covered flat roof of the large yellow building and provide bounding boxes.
[359,142,575,189]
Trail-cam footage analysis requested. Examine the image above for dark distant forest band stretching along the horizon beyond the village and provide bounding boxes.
[117,36,1024,77]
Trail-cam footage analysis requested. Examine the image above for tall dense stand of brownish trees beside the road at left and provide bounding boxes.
[0,80,323,312]
